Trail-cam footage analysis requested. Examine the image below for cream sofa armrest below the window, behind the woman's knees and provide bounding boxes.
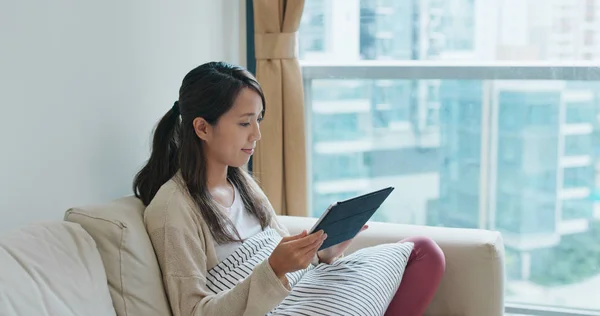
[279,216,504,316]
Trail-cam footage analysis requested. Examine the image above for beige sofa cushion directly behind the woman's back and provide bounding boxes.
[65,197,171,316]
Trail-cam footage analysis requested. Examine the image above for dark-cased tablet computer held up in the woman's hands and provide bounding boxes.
[310,187,394,250]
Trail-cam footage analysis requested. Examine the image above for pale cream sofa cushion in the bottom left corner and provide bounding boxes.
[0,222,115,316]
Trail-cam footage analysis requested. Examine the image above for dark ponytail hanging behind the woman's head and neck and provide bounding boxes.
[133,101,181,206]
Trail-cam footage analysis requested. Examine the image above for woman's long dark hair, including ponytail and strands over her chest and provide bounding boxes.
[133,62,271,243]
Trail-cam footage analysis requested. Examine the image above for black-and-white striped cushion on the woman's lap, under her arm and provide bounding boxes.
[207,229,413,316]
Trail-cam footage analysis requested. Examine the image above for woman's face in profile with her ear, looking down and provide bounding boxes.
[194,88,263,167]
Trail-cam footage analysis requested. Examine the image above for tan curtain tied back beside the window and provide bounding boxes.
[252,0,307,216]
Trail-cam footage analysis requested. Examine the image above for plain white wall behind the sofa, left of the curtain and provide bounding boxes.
[0,0,245,231]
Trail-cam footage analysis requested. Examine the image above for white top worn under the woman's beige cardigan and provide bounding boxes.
[214,186,262,262]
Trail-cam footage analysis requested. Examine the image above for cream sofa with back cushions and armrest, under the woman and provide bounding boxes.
[0,197,504,316]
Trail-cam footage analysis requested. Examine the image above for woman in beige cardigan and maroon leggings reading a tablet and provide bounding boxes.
[133,62,445,316]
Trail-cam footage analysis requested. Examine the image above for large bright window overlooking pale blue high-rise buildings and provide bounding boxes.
[299,0,600,314]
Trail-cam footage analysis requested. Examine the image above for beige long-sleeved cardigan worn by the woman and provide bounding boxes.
[144,175,298,316]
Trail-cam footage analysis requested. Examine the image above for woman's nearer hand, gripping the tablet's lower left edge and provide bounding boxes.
[269,230,327,280]
